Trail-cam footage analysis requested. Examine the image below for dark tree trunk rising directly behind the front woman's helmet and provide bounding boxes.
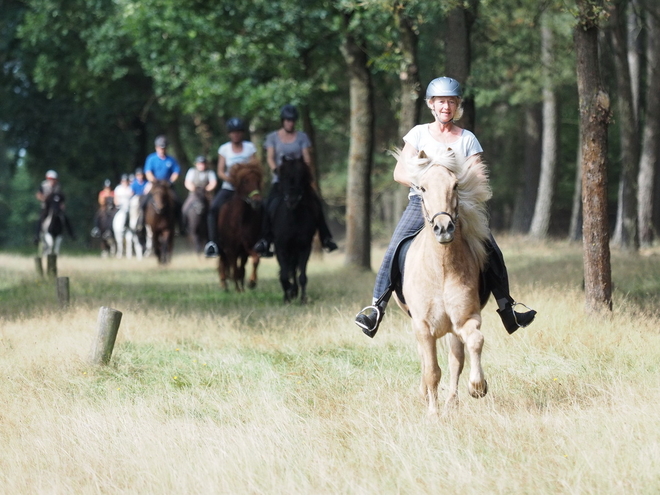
[446,0,477,131]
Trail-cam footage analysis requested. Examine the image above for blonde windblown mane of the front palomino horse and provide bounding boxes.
[392,149,492,268]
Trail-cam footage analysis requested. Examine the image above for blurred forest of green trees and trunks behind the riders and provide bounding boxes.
[0,0,660,267]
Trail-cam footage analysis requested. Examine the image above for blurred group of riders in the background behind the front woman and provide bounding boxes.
[37,104,337,258]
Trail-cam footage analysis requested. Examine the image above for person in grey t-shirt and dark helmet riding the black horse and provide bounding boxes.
[254,104,337,256]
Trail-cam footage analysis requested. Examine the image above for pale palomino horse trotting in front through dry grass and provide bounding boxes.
[397,150,491,414]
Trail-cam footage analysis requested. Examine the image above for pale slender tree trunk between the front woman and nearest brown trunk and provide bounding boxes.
[529,20,559,239]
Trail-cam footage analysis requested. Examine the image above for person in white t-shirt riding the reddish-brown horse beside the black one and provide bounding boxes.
[204,117,259,258]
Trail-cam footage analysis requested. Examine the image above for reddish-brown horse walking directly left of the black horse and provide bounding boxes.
[218,164,263,292]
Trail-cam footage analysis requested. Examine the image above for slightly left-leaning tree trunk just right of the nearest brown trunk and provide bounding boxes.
[609,0,639,250]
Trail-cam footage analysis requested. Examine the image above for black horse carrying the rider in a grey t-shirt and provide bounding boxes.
[271,157,320,303]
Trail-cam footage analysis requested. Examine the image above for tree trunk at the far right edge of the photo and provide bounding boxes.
[637,0,660,247]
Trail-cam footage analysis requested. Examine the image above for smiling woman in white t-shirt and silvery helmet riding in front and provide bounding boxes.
[355,77,536,337]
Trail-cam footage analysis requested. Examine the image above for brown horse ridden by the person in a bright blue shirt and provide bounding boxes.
[144,180,176,265]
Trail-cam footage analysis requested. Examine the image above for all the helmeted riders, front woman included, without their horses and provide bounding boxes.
[37,85,536,337]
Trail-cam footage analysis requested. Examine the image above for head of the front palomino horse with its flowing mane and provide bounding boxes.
[407,149,491,250]
